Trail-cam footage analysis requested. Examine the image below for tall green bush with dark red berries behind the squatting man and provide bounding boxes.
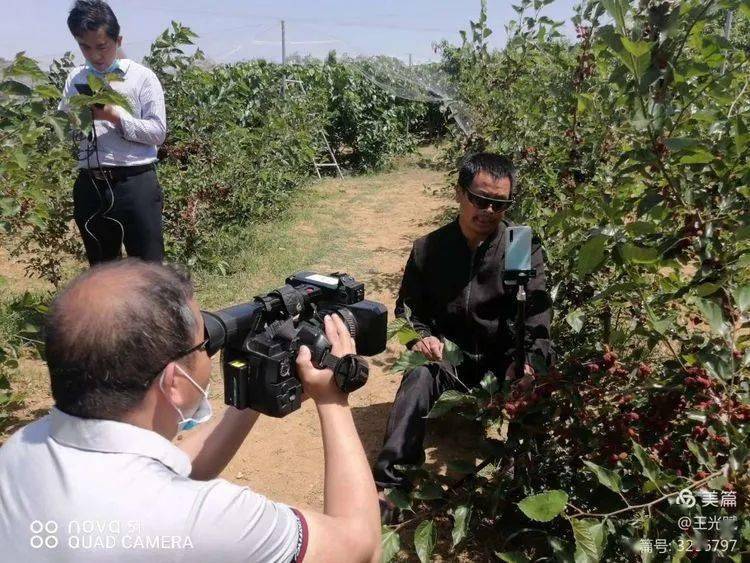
[384,0,750,562]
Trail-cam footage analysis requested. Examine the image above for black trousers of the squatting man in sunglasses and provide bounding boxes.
[373,364,490,489]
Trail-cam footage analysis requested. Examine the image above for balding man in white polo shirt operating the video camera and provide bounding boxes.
[0,259,380,563]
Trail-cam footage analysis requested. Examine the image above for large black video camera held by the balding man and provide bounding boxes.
[201,272,388,417]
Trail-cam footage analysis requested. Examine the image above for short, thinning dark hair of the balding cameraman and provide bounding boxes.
[45,259,197,420]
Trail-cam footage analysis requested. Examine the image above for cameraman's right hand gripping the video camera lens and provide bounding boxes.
[297,315,357,403]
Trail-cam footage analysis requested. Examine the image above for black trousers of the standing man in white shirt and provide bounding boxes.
[73,170,164,266]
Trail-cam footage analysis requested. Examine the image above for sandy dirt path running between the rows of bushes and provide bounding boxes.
[209,168,464,509]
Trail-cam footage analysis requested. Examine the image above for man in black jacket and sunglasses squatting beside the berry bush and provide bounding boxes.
[374,153,553,523]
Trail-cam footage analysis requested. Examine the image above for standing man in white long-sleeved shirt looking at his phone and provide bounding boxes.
[60,0,167,265]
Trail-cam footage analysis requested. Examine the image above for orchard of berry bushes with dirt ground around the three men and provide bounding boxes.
[0,0,750,563]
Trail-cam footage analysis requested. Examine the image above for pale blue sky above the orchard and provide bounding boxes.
[0,0,576,64]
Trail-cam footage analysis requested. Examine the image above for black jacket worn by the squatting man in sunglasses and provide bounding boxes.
[396,219,553,378]
